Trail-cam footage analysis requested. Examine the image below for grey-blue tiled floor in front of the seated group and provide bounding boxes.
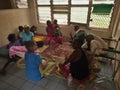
[0,57,115,90]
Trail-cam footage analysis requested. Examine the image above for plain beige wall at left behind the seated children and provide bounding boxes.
[0,9,32,46]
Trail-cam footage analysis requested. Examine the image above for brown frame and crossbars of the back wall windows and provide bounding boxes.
[36,0,112,29]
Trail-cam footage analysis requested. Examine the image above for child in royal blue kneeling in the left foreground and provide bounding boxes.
[25,41,44,81]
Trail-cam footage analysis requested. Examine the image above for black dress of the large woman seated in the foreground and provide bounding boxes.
[70,49,89,80]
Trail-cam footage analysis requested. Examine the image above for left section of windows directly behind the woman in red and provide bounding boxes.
[37,0,69,25]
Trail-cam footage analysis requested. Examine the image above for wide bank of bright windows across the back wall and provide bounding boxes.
[37,0,114,28]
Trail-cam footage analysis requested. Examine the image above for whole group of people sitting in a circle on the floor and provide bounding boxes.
[0,20,108,90]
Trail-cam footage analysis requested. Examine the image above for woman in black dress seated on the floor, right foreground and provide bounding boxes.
[60,39,89,82]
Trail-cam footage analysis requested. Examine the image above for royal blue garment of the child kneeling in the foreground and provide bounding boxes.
[25,52,42,81]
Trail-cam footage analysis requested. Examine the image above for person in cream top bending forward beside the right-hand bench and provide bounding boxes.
[82,34,108,55]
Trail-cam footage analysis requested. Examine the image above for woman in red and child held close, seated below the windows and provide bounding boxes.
[45,19,63,45]
